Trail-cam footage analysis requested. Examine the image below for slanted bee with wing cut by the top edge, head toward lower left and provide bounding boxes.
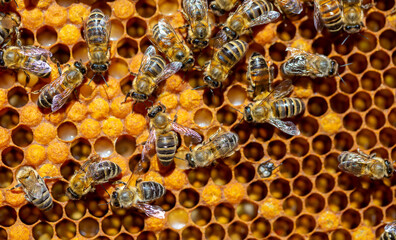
[219,0,280,41]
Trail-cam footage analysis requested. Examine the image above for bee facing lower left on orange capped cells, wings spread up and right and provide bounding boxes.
[124,46,182,102]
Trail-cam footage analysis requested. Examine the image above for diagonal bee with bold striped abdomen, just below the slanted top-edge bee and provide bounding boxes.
[203,40,248,88]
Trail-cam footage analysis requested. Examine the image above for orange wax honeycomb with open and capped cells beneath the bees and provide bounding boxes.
[0,0,396,240]
